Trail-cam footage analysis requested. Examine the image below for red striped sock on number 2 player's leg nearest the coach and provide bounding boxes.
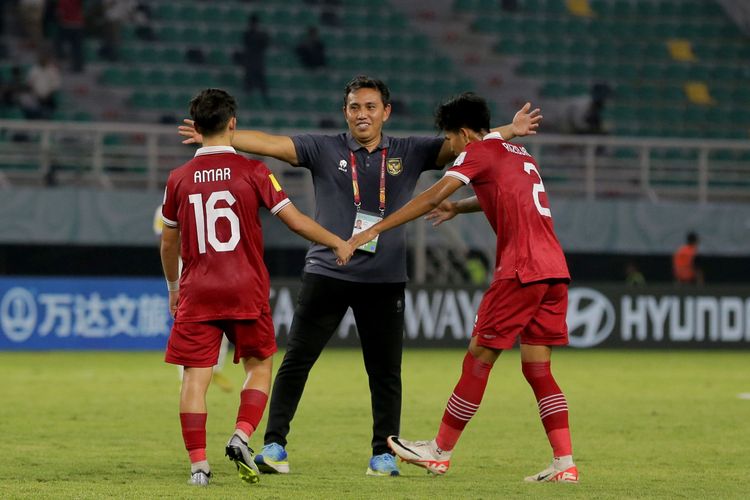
[435,352,492,451]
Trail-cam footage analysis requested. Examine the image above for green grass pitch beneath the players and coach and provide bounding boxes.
[0,350,750,498]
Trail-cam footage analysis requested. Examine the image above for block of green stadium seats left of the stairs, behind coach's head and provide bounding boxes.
[88,0,488,130]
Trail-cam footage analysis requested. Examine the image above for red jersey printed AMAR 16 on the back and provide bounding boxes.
[162,146,291,321]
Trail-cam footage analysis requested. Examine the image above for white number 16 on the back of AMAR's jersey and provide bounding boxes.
[188,191,240,253]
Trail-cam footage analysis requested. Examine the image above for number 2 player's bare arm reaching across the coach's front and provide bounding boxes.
[349,177,464,248]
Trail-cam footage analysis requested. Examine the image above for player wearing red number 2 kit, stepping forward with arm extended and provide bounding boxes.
[349,93,578,483]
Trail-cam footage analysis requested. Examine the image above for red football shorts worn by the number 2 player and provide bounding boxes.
[472,279,568,349]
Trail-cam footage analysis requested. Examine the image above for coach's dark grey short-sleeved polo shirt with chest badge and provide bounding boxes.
[292,132,443,283]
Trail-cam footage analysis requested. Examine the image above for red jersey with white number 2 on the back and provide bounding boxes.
[445,133,570,283]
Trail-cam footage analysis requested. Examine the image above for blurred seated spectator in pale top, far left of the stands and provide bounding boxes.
[18,51,62,120]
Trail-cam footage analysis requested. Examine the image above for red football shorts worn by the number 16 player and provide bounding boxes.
[164,312,277,368]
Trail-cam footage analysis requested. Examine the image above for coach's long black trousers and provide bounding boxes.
[264,273,404,455]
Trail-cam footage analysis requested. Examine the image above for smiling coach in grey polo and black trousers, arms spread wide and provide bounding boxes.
[180,75,541,476]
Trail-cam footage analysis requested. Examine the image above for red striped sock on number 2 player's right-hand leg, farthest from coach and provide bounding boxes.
[521,362,573,457]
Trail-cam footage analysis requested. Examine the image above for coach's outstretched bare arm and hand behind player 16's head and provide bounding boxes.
[177,118,297,166]
